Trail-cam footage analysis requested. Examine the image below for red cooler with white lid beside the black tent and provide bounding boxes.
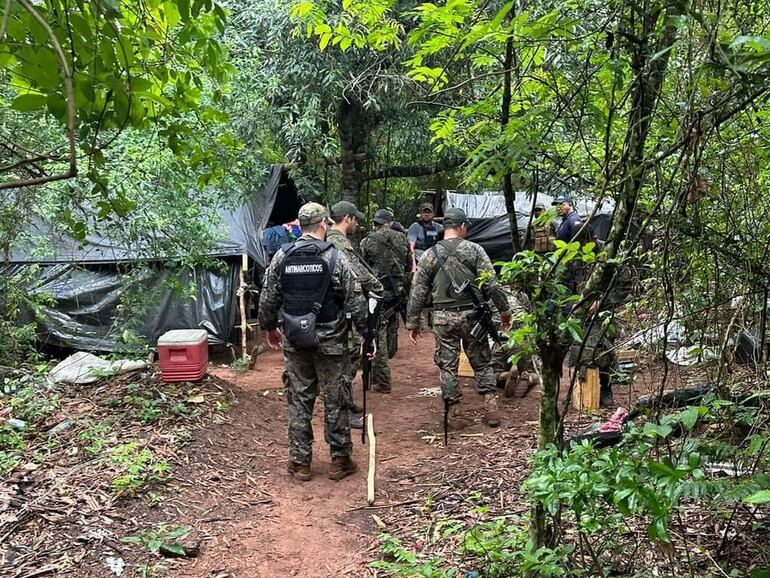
[158,329,209,383]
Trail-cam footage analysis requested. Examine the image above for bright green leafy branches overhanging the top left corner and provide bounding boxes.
[0,0,232,189]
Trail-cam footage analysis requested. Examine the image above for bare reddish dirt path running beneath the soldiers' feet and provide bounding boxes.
[154,334,538,578]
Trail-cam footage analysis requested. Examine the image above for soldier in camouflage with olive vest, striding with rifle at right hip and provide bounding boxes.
[406,208,511,427]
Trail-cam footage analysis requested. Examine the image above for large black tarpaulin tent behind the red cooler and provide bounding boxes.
[6,165,299,351]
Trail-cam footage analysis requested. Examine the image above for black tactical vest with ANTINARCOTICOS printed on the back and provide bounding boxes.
[281,241,339,323]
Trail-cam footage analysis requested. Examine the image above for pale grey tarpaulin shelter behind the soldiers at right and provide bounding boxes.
[442,191,615,262]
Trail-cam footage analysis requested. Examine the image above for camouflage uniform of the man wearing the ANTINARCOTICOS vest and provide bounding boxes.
[259,235,366,465]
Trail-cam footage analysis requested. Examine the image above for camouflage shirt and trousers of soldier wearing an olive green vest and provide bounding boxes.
[406,238,509,404]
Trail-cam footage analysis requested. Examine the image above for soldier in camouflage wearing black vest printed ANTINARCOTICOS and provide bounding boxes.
[259,203,366,481]
